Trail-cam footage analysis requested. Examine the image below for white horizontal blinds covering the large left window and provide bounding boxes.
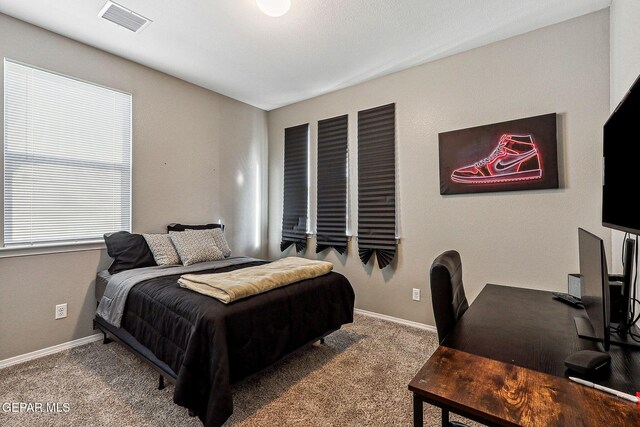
[4,59,131,246]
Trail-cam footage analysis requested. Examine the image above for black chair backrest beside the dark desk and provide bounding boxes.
[429,251,469,343]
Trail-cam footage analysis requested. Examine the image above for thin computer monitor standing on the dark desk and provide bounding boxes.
[578,228,610,351]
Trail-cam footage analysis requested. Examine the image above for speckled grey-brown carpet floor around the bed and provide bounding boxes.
[0,315,475,427]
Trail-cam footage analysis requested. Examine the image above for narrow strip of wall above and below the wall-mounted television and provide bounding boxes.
[610,0,640,272]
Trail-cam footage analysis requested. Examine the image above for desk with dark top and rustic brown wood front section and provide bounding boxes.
[409,285,640,426]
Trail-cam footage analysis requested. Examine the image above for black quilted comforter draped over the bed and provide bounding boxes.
[122,262,354,427]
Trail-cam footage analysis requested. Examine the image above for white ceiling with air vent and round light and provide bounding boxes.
[0,0,611,110]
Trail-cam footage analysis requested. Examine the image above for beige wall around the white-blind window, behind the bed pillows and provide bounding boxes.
[0,14,267,360]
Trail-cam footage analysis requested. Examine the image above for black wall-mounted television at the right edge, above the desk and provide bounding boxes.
[602,73,640,234]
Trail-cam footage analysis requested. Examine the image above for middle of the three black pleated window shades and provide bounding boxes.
[316,114,348,254]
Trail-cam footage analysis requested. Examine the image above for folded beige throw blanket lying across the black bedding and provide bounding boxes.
[178,257,333,304]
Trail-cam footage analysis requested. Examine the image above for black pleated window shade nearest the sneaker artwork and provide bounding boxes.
[358,104,396,268]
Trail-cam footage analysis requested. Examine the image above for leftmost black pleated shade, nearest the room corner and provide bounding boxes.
[280,123,309,252]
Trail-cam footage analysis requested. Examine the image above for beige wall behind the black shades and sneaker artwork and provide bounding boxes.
[268,10,610,324]
